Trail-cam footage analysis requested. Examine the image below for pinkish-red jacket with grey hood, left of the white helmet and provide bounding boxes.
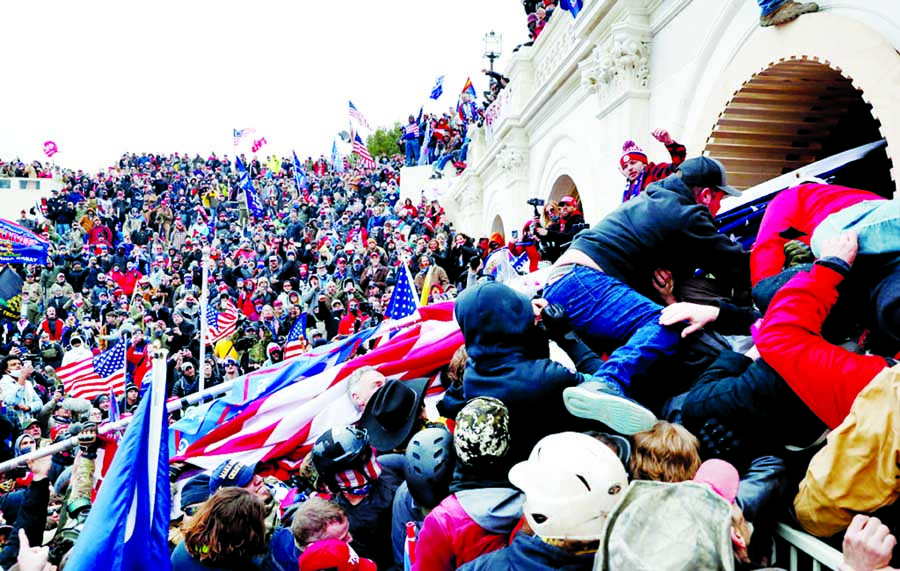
[412,488,524,571]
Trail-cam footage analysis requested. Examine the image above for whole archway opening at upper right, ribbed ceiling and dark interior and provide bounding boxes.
[705,58,894,195]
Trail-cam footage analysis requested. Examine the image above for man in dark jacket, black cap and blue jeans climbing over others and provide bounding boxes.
[544,157,750,434]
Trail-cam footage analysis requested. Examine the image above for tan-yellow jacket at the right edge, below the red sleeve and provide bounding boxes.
[794,365,900,537]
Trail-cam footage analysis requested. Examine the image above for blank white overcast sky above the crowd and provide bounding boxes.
[0,0,526,169]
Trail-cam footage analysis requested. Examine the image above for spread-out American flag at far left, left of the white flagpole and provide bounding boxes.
[56,341,125,400]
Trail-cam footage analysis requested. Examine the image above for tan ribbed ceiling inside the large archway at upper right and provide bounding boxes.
[706,60,861,189]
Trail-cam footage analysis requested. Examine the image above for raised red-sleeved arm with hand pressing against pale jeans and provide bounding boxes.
[754,232,895,429]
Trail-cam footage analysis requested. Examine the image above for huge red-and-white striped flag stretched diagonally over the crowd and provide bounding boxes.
[172,302,463,476]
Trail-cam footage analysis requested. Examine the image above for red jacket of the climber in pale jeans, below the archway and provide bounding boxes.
[750,183,885,286]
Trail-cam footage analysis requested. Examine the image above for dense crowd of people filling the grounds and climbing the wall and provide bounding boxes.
[0,0,900,571]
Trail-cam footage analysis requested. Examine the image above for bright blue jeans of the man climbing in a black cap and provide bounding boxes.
[544,266,680,393]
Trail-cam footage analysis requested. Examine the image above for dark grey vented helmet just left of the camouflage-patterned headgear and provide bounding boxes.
[404,426,456,510]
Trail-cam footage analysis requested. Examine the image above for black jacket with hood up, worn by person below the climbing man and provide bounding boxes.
[450,282,587,462]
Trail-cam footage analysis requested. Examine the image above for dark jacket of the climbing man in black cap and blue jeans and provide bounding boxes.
[571,176,750,299]
